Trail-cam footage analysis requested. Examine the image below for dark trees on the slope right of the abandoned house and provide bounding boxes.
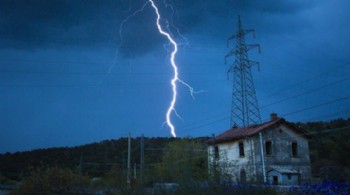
[296,119,350,182]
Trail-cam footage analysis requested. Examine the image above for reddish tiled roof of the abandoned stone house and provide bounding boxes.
[206,118,304,144]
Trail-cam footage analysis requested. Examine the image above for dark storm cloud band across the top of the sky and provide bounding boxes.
[0,0,322,57]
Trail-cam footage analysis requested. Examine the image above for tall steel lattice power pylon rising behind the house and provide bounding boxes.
[225,16,261,127]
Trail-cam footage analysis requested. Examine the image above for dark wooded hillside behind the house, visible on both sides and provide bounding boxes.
[0,119,350,184]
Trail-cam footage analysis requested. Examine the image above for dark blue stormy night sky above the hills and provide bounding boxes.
[0,0,350,153]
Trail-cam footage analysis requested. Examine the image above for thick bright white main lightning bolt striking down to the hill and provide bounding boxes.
[149,0,179,137]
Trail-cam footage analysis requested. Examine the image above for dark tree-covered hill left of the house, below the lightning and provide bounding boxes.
[0,137,208,180]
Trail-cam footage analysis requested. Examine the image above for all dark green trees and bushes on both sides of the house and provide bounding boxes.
[0,119,350,194]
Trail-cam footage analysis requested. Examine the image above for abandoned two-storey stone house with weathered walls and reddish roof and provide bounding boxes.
[207,114,311,185]
